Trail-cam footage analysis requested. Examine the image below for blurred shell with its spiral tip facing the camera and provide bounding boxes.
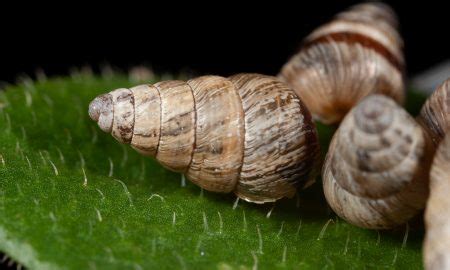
[322,95,431,229]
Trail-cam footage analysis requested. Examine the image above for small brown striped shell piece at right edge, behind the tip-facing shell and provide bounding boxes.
[418,78,450,146]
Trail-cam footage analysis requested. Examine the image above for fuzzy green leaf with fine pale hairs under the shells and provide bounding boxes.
[0,74,423,269]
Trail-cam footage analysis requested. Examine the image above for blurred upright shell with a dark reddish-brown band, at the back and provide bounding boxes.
[279,2,405,124]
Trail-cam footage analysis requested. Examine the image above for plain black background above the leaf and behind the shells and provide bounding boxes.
[0,1,450,82]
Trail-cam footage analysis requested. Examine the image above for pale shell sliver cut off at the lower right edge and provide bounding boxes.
[424,134,450,269]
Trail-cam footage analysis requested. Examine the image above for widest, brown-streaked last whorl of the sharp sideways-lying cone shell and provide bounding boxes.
[229,74,318,203]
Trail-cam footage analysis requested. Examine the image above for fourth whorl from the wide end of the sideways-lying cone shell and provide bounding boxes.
[130,84,161,156]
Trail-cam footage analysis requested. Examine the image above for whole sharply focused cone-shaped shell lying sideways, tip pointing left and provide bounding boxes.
[89,74,319,203]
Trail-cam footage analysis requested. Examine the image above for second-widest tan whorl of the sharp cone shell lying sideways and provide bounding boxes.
[187,76,244,192]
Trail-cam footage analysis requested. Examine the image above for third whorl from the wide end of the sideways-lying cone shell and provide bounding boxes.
[155,81,195,172]
